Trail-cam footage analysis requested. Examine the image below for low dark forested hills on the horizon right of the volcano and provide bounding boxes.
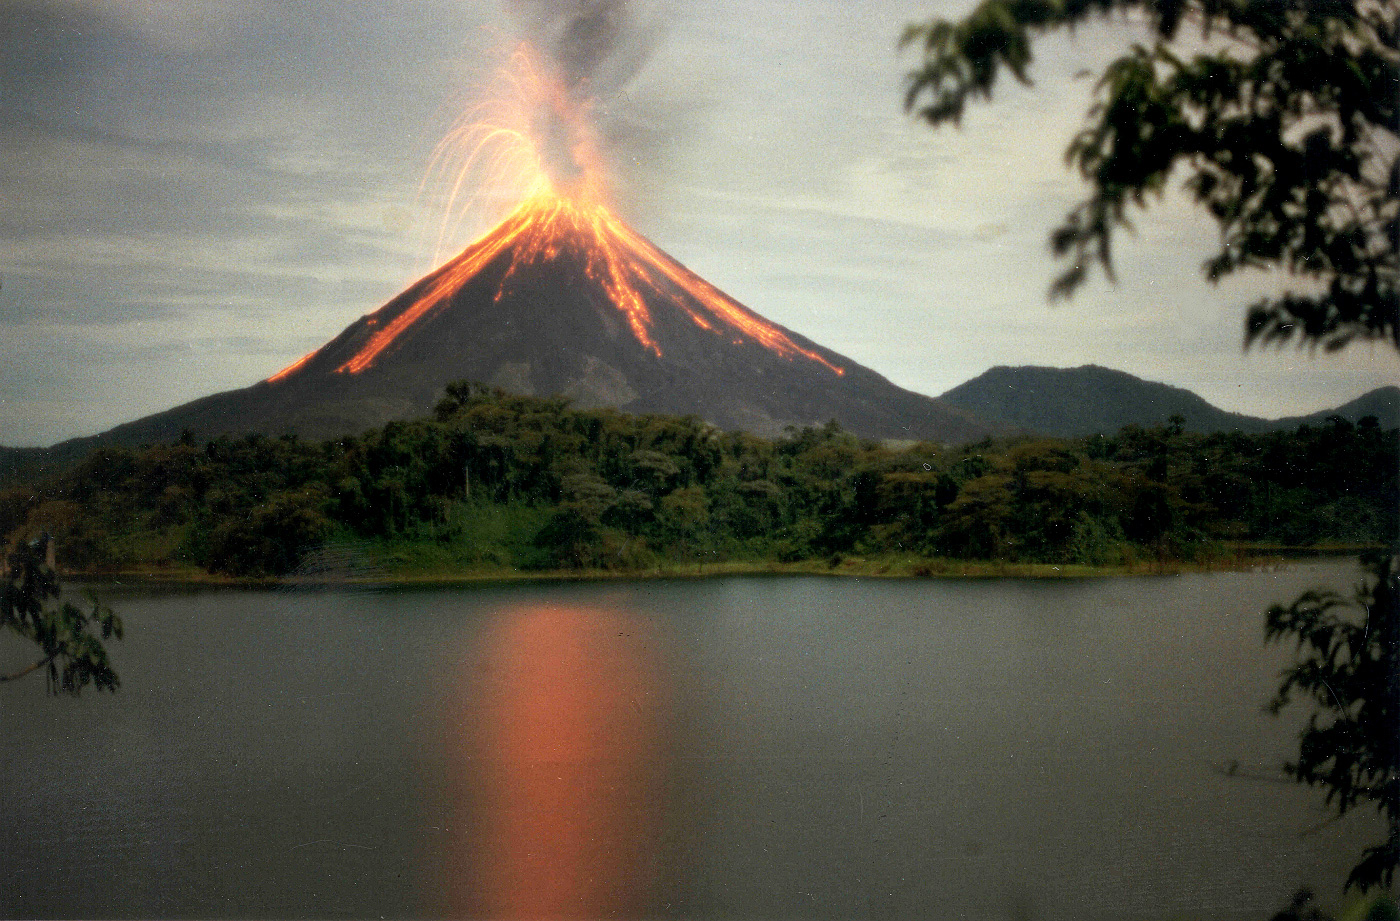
[939,365,1400,438]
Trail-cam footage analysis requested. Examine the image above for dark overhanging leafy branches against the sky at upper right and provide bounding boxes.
[903,0,1400,349]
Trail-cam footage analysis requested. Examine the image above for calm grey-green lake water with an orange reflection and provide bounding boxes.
[0,563,1378,921]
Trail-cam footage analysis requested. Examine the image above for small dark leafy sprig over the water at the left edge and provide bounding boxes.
[0,537,122,696]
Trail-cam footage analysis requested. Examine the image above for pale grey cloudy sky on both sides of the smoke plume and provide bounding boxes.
[0,0,1400,447]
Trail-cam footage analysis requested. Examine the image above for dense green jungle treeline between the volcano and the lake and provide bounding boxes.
[0,382,1400,577]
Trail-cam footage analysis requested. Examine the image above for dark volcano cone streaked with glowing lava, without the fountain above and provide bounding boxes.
[63,196,1004,444]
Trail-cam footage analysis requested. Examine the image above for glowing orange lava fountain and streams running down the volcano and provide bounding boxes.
[269,46,844,382]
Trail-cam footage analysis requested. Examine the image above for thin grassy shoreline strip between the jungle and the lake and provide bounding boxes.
[59,546,1369,588]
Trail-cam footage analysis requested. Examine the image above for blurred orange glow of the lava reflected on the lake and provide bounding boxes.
[444,606,665,918]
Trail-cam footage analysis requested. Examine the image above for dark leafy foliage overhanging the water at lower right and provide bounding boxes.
[1264,553,1400,890]
